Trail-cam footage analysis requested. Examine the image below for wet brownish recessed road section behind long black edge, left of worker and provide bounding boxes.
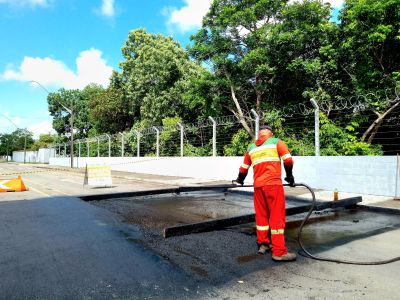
[91,193,253,229]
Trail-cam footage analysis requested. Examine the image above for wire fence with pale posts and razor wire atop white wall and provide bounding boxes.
[49,93,400,157]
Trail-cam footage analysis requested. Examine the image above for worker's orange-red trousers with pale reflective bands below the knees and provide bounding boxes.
[254,185,287,256]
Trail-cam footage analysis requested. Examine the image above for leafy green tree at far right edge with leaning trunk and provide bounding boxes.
[340,0,400,143]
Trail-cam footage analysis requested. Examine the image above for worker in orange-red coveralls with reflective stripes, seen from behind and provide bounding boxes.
[236,125,296,261]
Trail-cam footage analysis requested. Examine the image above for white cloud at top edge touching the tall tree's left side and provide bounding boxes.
[165,0,213,32]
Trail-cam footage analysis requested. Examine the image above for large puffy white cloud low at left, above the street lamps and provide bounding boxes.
[0,48,113,89]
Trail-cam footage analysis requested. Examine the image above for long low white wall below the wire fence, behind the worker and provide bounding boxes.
[50,156,400,196]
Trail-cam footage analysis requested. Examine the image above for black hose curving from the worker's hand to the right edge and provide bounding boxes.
[285,183,400,265]
